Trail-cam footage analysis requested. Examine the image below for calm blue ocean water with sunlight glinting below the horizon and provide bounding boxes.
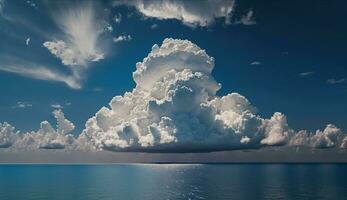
[0,164,347,200]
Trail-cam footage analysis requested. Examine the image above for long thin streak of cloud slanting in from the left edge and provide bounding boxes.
[0,62,81,89]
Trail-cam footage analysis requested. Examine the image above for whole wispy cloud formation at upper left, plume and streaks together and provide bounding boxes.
[0,0,107,89]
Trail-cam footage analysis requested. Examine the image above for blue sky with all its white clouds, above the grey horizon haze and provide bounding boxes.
[0,0,347,159]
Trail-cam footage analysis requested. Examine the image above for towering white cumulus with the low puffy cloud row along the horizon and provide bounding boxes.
[0,39,347,152]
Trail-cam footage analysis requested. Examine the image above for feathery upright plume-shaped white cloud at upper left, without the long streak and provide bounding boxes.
[43,3,105,88]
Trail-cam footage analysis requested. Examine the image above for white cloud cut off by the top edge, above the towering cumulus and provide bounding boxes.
[114,0,234,27]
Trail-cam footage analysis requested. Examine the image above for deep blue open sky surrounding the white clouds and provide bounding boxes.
[0,0,347,138]
